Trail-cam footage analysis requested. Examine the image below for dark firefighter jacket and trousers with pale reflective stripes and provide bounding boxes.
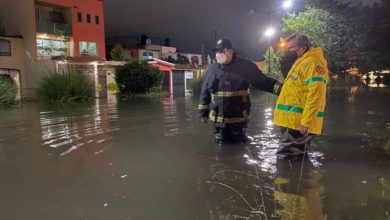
[198,54,281,143]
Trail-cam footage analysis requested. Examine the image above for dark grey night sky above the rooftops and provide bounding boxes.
[104,0,380,60]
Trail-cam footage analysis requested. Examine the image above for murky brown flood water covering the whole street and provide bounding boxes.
[0,87,390,220]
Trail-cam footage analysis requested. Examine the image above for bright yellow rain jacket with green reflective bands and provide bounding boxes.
[274,48,329,134]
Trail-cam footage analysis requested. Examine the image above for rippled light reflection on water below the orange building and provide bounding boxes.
[40,100,118,156]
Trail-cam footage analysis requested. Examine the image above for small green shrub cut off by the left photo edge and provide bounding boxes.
[0,75,18,107]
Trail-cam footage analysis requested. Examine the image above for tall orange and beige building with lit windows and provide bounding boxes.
[0,0,105,96]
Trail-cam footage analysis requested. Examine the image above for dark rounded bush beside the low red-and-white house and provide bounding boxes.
[115,61,164,95]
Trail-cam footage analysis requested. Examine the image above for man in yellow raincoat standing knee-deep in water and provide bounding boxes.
[274,34,329,158]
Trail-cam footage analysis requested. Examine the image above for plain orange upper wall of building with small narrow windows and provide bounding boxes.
[39,0,106,59]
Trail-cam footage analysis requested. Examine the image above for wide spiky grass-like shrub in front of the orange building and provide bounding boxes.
[37,71,95,102]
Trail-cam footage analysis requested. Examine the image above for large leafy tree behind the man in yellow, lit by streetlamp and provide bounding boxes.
[283,0,390,73]
